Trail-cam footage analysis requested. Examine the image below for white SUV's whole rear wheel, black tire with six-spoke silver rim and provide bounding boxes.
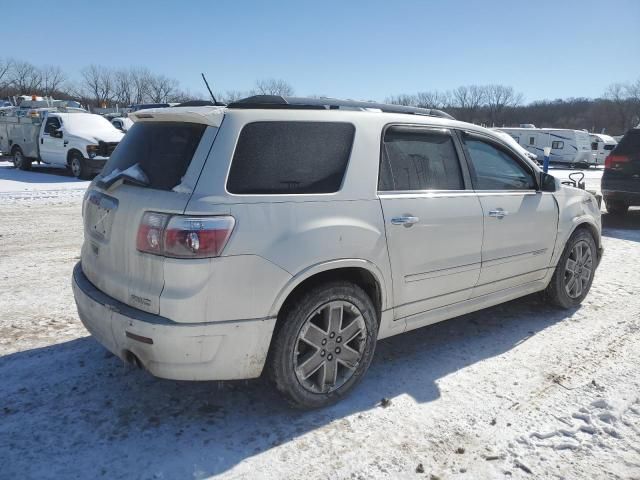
[268,281,378,409]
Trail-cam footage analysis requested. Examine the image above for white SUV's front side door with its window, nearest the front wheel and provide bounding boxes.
[463,134,558,297]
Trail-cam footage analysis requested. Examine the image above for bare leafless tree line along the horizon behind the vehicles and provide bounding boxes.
[0,58,640,135]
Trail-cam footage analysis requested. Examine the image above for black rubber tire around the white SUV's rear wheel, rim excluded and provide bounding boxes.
[267,281,378,409]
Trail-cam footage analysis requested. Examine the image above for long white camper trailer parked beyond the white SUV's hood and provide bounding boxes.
[500,126,596,167]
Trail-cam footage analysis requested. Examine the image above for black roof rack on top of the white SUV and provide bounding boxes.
[227,95,455,120]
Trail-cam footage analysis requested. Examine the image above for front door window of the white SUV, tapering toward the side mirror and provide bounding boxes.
[465,138,536,190]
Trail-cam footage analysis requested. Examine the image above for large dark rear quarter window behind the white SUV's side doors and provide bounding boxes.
[227,122,355,195]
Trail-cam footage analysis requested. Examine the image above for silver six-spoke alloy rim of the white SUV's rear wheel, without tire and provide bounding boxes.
[293,300,367,394]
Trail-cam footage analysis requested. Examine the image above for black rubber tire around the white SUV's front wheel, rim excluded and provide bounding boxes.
[546,228,598,308]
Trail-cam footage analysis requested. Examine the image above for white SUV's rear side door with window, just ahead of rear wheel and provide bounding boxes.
[378,125,482,322]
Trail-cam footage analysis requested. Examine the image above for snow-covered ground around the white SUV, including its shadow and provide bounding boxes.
[0,164,640,479]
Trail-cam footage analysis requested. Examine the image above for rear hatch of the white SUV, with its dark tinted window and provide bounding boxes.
[82,118,217,314]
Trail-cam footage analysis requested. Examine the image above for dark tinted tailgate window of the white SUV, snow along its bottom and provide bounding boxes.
[102,122,207,190]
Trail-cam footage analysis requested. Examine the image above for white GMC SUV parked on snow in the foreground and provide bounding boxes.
[73,96,602,408]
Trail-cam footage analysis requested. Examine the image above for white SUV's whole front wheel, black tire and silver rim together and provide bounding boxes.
[546,229,598,308]
